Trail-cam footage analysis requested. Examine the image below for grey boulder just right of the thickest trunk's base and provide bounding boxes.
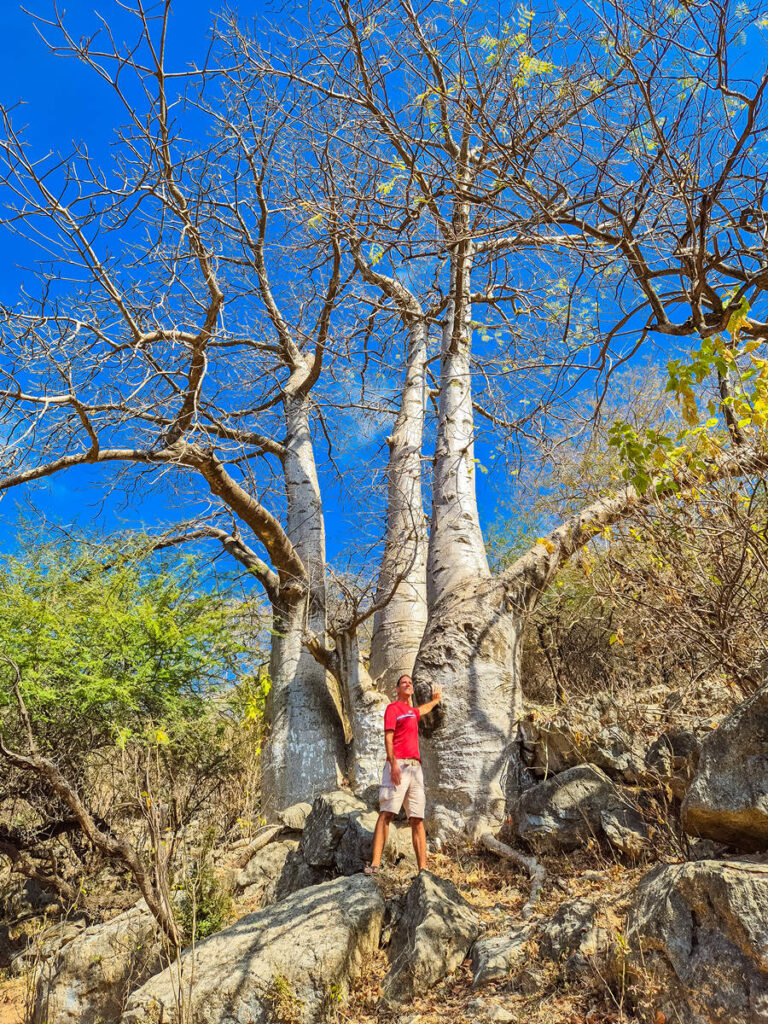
[512,765,626,851]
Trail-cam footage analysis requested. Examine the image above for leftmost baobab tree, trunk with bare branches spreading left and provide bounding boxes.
[0,4,354,805]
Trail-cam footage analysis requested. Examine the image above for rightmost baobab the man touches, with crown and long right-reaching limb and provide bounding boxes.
[252,0,765,827]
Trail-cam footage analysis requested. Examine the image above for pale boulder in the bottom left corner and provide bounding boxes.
[32,900,163,1024]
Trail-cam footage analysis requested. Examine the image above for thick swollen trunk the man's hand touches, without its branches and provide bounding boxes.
[415,243,521,833]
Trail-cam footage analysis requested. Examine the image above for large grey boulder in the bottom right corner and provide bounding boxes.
[616,860,768,1024]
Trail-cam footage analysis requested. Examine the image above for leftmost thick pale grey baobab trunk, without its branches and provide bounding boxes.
[262,395,345,811]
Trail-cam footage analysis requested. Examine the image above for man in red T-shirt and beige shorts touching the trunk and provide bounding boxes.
[366,676,442,874]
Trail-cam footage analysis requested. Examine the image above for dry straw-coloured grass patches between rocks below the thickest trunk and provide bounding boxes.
[335,848,647,1024]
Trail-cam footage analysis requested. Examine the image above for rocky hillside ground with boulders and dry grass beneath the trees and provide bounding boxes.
[0,671,768,1024]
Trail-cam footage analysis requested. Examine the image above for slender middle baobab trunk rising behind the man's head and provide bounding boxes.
[371,319,427,693]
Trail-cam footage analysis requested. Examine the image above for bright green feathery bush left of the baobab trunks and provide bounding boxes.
[0,540,260,750]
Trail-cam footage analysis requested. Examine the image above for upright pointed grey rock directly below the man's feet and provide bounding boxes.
[383,871,480,1005]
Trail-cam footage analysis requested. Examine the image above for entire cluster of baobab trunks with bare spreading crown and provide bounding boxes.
[0,0,767,829]
